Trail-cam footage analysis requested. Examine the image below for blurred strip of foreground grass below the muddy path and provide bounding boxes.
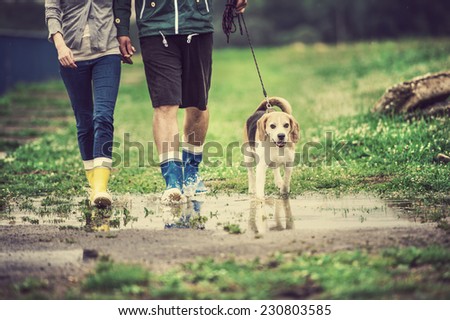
[10,246,450,300]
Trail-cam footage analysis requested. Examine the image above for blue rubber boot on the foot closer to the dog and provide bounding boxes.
[182,149,208,196]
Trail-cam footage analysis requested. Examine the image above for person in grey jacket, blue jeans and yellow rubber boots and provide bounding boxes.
[45,0,121,207]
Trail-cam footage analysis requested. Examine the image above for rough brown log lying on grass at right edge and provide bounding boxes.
[372,71,450,114]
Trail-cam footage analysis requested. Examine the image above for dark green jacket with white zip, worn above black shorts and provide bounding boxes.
[114,0,213,37]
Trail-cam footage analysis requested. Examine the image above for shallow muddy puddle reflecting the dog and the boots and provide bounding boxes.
[0,195,419,234]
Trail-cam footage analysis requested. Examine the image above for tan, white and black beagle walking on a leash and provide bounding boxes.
[243,97,299,199]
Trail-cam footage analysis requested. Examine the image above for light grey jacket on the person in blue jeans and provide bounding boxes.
[45,0,119,52]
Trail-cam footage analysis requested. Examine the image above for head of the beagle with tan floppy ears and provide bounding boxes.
[256,112,300,148]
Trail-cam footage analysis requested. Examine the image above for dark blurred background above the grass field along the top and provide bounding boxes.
[0,0,450,47]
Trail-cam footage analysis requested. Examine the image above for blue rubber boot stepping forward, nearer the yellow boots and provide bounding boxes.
[160,159,185,203]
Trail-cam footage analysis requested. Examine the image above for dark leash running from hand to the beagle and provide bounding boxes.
[222,0,273,112]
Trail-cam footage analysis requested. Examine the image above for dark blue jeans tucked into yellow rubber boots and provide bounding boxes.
[60,55,121,160]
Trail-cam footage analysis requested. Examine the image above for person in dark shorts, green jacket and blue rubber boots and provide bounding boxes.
[114,0,247,203]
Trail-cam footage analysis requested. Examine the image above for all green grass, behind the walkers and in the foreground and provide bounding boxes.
[0,39,450,299]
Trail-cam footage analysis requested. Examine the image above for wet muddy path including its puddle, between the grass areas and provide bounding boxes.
[0,194,449,291]
